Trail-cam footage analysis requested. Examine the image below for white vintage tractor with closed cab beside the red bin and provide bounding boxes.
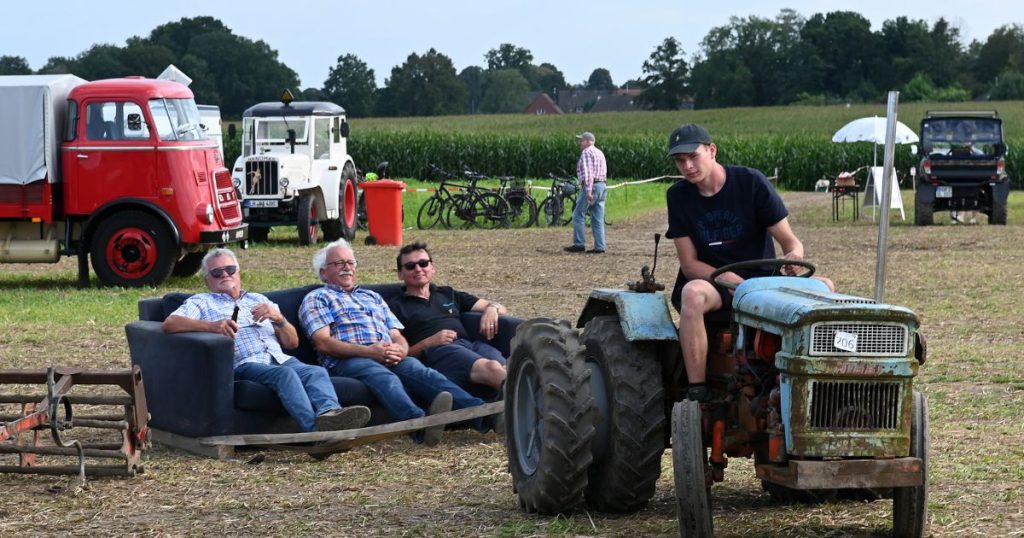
[231,90,357,245]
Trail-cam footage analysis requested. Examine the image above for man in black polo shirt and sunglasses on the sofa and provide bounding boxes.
[388,243,508,399]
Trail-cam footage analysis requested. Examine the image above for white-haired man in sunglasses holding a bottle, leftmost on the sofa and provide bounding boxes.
[163,248,370,431]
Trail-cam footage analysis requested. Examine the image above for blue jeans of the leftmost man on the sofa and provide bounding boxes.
[234,358,341,431]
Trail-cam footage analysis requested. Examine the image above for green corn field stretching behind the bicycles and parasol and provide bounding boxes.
[227,101,1024,191]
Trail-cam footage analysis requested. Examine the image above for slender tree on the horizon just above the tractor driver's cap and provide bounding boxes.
[634,37,690,111]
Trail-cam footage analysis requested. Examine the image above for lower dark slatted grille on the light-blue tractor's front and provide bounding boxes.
[810,381,901,430]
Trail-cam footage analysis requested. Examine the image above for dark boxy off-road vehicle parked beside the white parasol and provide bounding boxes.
[914,111,1010,225]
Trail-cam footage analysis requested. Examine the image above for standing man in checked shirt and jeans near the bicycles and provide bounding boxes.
[564,132,608,254]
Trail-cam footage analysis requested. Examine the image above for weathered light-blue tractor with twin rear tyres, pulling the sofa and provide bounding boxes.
[505,237,928,537]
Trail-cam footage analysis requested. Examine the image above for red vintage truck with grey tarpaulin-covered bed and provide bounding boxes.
[0,75,248,287]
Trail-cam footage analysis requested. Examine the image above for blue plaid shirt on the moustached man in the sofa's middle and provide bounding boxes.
[299,284,406,368]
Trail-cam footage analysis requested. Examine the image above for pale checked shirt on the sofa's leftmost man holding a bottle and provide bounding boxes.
[171,291,292,368]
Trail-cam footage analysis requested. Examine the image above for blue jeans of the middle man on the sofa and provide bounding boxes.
[331,357,483,420]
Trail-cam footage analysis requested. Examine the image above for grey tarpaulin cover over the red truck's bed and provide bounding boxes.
[0,75,85,184]
